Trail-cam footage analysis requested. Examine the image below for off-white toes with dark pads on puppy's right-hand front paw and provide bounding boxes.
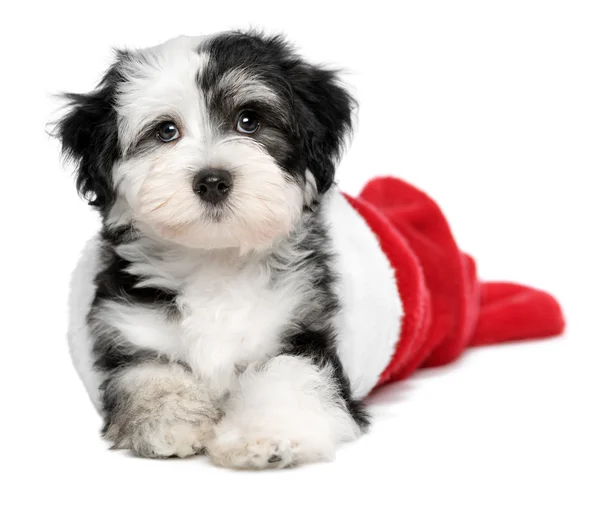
[207,430,302,469]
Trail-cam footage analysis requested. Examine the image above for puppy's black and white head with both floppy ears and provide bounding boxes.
[57,33,353,250]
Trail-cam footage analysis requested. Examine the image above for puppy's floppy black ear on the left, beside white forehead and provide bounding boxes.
[54,57,120,211]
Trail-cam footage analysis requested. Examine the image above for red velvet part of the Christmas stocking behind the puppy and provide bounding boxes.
[346,177,565,385]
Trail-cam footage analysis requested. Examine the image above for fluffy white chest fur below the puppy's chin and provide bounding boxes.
[132,262,302,394]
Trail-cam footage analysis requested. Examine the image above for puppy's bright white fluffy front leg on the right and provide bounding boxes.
[207,355,366,469]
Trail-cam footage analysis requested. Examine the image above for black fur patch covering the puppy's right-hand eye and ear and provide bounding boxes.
[198,32,355,193]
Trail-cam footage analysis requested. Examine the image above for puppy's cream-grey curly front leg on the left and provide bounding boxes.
[104,362,220,457]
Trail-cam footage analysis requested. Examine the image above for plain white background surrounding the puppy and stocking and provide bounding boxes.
[0,0,600,505]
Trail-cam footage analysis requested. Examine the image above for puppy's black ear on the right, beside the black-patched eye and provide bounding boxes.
[287,60,356,193]
